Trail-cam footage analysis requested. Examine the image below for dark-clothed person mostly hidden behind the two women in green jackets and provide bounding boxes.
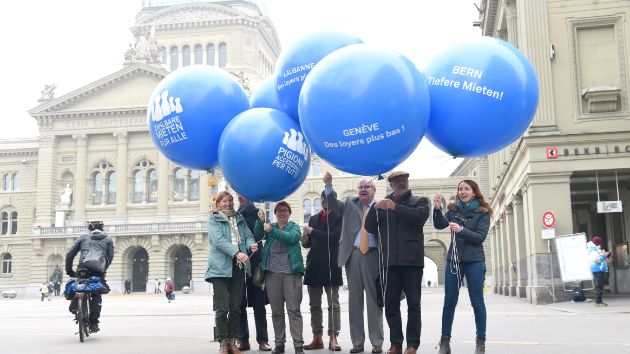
[236,195,271,352]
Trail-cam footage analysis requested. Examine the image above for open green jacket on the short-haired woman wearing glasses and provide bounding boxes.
[254,220,304,274]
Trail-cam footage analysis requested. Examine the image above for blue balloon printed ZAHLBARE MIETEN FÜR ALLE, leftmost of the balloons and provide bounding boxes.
[147,65,249,170]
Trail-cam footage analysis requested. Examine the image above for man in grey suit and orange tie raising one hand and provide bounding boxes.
[324,172,383,353]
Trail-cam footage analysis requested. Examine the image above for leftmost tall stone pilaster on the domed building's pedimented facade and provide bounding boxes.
[33,135,59,227]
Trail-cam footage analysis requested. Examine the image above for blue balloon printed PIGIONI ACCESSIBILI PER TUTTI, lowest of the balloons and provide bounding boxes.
[219,108,311,202]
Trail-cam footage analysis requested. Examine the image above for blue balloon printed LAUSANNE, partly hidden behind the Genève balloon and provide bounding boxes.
[276,31,363,121]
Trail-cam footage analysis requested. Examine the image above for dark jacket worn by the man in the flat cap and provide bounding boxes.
[365,191,429,267]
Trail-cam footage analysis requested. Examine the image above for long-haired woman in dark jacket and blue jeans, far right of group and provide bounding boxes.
[433,179,492,354]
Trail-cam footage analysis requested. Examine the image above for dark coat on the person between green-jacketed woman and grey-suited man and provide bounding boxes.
[302,212,343,286]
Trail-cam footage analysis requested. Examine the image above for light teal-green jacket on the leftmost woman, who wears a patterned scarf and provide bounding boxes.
[205,213,255,281]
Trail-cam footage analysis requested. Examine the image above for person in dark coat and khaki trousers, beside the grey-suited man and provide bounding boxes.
[301,191,343,351]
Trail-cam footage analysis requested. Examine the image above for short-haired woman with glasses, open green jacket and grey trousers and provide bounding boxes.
[254,201,304,354]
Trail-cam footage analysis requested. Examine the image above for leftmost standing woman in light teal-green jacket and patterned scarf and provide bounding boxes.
[205,192,258,354]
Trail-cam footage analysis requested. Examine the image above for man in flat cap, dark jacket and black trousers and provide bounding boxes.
[365,171,429,354]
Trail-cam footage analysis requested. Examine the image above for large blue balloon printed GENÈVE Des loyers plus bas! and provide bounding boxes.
[299,44,430,175]
